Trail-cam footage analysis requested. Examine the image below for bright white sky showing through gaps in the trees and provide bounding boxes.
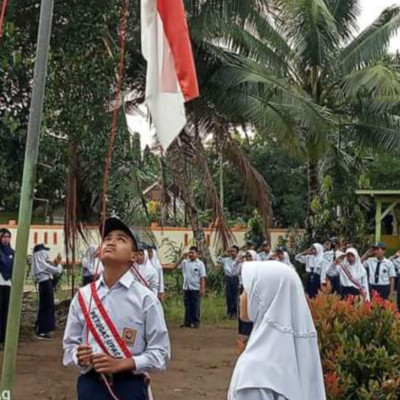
[129,0,400,148]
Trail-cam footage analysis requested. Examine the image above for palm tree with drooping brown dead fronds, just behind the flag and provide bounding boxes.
[127,0,271,265]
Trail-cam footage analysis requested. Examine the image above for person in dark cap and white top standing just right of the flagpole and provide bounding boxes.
[32,244,62,340]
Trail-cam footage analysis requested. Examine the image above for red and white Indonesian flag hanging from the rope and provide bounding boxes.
[141,0,199,149]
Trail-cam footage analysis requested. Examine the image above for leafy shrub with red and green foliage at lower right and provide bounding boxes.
[310,293,400,400]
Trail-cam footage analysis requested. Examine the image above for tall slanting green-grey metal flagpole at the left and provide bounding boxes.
[1,0,54,392]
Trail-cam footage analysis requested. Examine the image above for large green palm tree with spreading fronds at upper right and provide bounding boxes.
[208,0,400,232]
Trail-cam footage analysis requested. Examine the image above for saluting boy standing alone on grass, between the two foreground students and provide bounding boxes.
[177,246,207,329]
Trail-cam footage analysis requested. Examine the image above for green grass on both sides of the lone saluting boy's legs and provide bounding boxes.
[164,295,237,328]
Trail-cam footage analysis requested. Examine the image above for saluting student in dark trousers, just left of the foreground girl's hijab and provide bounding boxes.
[218,246,239,318]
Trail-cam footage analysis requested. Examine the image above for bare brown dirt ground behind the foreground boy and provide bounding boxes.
[0,325,237,400]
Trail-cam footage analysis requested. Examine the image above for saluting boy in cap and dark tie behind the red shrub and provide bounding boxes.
[362,242,396,300]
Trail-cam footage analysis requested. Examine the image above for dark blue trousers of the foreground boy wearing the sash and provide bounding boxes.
[77,372,148,400]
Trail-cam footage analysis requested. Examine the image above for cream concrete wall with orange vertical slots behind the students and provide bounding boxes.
[0,225,300,265]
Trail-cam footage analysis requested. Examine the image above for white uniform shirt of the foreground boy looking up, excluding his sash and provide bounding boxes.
[63,270,170,374]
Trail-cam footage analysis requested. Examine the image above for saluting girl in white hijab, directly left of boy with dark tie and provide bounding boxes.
[336,248,370,301]
